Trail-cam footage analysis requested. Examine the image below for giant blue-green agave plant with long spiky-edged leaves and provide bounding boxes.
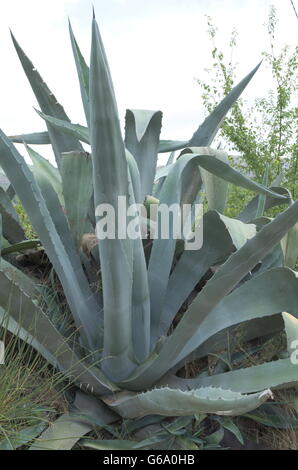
[0,12,298,448]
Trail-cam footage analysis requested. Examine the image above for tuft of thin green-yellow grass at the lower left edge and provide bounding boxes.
[0,330,67,449]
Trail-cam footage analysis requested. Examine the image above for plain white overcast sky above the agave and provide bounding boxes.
[0,0,298,165]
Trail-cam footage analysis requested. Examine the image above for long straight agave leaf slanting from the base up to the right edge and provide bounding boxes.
[126,197,298,389]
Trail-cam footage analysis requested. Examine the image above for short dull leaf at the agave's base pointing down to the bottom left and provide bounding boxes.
[30,391,117,450]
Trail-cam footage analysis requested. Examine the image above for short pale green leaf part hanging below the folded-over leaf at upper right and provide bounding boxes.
[200,153,229,213]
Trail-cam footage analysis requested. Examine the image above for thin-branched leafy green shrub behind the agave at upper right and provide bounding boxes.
[198,6,298,216]
